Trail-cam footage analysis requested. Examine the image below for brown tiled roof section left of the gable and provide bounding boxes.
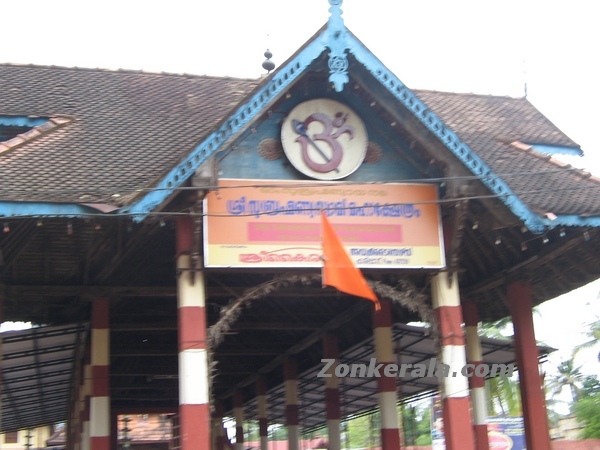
[0,65,257,203]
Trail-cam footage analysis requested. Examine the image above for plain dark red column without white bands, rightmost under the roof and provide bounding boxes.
[507,281,550,450]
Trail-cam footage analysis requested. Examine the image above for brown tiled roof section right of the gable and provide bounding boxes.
[417,91,600,215]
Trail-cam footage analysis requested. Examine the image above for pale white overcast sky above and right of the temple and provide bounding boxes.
[0,0,600,373]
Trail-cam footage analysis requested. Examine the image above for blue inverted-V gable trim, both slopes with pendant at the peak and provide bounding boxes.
[122,15,548,233]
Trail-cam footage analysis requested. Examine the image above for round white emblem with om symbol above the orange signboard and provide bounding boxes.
[281,99,368,180]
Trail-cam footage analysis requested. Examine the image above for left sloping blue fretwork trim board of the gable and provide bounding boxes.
[121,37,326,222]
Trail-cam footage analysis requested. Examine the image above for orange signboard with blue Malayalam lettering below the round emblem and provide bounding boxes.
[204,179,445,269]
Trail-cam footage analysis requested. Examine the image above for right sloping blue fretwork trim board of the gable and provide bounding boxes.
[347,35,546,233]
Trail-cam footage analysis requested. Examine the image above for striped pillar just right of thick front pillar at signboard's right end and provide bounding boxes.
[462,300,489,450]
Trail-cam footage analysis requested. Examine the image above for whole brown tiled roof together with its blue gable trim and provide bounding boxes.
[0,6,600,232]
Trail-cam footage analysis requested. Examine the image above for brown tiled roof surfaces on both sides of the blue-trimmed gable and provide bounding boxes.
[0,65,600,215]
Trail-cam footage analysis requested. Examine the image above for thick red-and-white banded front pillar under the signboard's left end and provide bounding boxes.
[176,216,210,450]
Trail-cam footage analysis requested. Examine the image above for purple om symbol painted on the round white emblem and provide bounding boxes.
[292,112,354,173]
